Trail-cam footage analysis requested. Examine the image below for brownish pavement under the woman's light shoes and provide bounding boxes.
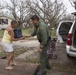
[0,59,37,75]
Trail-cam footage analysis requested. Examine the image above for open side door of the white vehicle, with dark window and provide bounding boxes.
[56,21,73,43]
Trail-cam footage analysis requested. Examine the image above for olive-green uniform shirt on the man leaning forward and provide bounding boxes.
[31,21,50,46]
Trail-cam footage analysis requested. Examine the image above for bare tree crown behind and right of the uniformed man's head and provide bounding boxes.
[28,0,66,26]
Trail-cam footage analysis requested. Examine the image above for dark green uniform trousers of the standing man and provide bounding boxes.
[40,44,49,71]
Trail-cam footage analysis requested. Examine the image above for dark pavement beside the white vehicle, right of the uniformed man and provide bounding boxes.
[50,43,76,75]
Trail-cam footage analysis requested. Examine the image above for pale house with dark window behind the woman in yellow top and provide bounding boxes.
[0,14,13,30]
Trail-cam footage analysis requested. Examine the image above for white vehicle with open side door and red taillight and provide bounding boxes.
[57,21,76,57]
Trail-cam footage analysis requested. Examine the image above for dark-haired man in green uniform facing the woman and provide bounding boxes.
[31,15,50,75]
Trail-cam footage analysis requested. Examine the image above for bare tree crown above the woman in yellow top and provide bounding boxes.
[2,0,30,25]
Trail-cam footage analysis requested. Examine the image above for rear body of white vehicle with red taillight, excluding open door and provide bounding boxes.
[66,21,76,57]
